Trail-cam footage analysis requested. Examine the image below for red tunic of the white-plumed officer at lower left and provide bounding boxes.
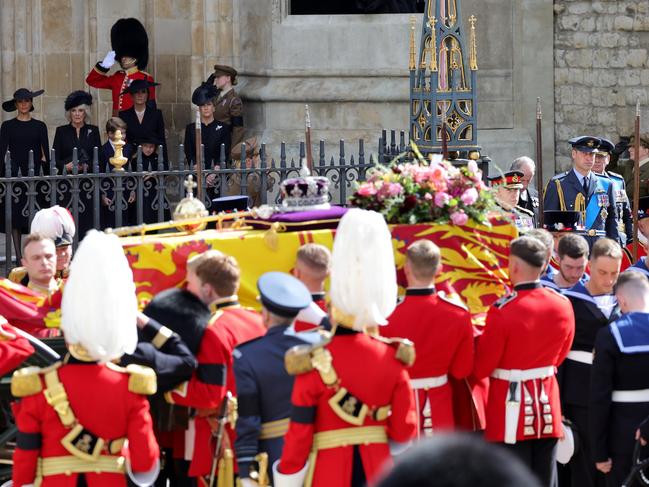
[12,358,160,487]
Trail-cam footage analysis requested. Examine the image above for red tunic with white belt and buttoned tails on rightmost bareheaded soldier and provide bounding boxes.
[474,281,575,442]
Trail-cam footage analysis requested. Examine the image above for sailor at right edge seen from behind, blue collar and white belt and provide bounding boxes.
[589,272,649,487]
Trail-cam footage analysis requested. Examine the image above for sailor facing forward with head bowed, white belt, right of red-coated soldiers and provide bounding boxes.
[559,239,622,487]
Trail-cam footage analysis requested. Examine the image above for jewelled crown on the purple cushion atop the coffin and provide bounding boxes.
[280,165,330,211]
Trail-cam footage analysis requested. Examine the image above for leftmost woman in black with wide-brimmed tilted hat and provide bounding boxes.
[0,88,50,255]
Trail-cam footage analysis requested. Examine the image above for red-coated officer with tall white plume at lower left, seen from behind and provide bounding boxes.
[11,231,159,487]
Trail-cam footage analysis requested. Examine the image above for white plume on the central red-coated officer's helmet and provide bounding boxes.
[330,208,397,330]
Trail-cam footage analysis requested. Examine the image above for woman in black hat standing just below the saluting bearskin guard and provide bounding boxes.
[119,79,168,161]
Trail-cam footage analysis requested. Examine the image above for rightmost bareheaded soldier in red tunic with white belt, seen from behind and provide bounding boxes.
[474,237,575,486]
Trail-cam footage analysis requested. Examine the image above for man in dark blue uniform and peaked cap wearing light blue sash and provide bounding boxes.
[543,136,619,247]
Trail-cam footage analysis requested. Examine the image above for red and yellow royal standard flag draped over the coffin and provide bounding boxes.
[122,217,517,323]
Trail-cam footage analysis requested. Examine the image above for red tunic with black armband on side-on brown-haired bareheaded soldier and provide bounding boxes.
[165,297,266,477]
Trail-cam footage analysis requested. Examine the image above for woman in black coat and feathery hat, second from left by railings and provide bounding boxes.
[53,91,101,240]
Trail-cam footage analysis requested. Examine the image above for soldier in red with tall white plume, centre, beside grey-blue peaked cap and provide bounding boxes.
[273,209,417,487]
